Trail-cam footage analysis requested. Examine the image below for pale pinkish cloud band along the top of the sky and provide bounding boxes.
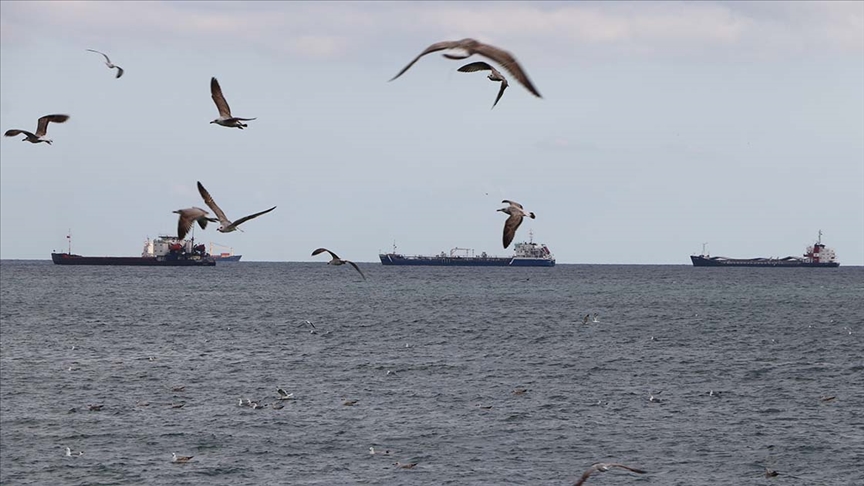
[0,1,864,58]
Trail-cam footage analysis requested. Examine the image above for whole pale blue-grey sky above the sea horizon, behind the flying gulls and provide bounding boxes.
[0,1,864,266]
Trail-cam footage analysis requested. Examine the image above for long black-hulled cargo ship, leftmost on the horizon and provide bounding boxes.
[51,235,216,267]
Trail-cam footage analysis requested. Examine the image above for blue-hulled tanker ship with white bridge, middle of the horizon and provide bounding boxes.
[378,231,555,267]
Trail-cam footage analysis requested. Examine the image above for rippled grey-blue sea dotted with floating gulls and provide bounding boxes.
[0,260,864,486]
